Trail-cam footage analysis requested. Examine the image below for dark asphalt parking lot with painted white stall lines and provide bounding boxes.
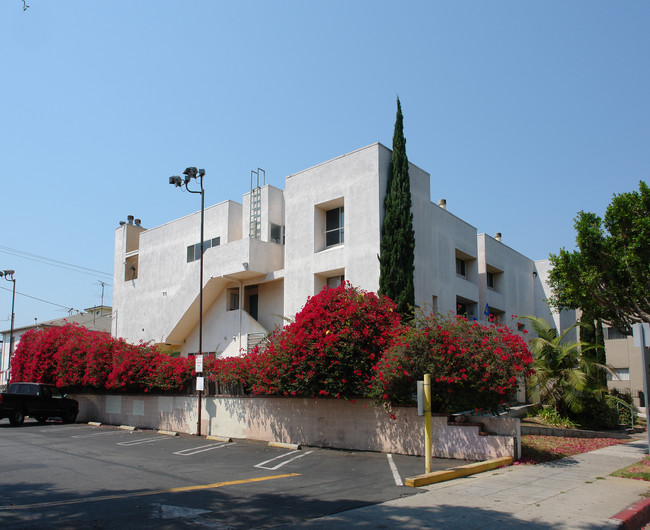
[0,420,458,528]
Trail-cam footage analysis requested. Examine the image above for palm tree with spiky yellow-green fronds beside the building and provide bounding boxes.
[524,316,608,414]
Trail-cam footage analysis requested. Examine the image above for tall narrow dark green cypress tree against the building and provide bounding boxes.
[379,98,415,318]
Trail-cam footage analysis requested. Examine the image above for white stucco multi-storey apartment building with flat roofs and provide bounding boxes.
[113,143,560,355]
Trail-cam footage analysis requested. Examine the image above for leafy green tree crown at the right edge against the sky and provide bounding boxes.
[549,181,650,334]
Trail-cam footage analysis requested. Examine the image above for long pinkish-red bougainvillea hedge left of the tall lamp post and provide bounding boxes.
[11,324,193,392]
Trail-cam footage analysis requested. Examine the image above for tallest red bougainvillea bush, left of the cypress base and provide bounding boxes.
[246,283,400,397]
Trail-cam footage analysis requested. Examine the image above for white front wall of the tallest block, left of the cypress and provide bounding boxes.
[284,144,389,316]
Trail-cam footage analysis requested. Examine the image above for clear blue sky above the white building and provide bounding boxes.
[0,0,650,329]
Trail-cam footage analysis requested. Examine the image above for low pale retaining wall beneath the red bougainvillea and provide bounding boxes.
[71,394,521,460]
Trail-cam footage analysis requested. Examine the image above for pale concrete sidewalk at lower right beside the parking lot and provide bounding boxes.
[292,439,650,530]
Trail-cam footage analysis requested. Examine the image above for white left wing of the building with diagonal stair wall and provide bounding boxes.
[113,190,283,354]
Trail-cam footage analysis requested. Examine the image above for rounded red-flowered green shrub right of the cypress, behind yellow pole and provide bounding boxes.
[372,314,532,412]
